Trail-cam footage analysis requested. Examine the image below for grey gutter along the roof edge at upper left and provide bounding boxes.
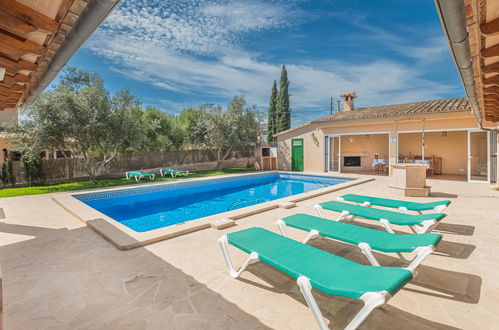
[22,0,121,107]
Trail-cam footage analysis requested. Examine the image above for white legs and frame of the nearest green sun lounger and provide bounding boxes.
[218,235,406,330]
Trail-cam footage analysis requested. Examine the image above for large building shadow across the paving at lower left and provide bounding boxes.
[0,223,267,329]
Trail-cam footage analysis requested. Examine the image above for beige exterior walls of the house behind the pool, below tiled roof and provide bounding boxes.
[277,110,499,182]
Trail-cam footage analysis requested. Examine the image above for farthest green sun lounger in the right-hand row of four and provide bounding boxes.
[338,194,451,214]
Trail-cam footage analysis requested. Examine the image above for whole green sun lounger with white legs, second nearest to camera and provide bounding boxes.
[276,213,442,270]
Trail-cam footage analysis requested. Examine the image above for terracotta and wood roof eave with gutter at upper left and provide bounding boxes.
[0,0,119,110]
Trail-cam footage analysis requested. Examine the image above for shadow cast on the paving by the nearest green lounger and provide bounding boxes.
[238,238,482,329]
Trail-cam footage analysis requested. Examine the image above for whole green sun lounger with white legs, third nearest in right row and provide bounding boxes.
[314,201,445,234]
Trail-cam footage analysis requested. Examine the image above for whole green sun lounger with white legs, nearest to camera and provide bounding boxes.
[218,227,413,330]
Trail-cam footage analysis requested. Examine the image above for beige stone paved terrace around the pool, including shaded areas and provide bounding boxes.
[0,177,499,330]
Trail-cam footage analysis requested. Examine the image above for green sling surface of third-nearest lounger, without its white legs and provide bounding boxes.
[319,201,445,226]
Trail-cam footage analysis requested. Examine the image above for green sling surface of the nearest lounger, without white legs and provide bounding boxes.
[227,227,412,298]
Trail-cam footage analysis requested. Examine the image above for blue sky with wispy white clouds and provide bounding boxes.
[61,0,464,125]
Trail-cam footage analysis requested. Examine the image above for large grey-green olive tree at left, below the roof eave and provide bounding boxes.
[10,68,156,182]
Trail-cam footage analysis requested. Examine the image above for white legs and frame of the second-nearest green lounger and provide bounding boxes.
[275,219,435,273]
